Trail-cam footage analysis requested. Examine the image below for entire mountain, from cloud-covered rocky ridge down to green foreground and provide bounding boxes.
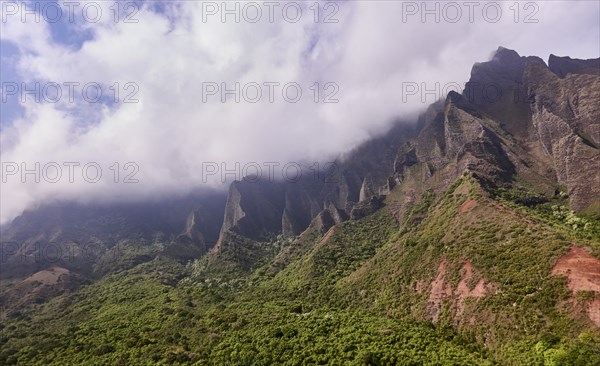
[0,47,600,365]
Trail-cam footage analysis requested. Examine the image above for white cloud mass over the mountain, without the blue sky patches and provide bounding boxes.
[1,1,600,222]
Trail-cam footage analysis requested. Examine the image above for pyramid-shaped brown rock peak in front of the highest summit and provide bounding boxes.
[395,92,516,197]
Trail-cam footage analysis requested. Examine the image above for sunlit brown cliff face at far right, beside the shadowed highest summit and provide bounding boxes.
[525,59,600,211]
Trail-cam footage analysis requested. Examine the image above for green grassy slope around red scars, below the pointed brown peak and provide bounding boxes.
[338,178,600,365]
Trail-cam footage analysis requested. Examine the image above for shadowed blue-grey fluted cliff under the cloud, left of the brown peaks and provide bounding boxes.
[221,125,415,243]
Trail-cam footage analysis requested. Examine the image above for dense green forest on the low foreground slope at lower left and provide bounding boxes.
[0,261,491,365]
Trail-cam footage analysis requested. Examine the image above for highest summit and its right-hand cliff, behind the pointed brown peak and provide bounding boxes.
[458,48,600,211]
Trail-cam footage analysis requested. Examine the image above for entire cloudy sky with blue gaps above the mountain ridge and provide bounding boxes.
[0,1,600,223]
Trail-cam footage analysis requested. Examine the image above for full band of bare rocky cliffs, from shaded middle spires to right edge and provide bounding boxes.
[217,47,600,266]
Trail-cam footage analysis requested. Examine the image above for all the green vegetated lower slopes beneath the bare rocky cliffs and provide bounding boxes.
[0,177,600,365]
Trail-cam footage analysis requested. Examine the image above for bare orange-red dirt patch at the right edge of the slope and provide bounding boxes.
[550,245,600,327]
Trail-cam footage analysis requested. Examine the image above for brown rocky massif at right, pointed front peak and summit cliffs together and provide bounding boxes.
[395,48,600,211]
